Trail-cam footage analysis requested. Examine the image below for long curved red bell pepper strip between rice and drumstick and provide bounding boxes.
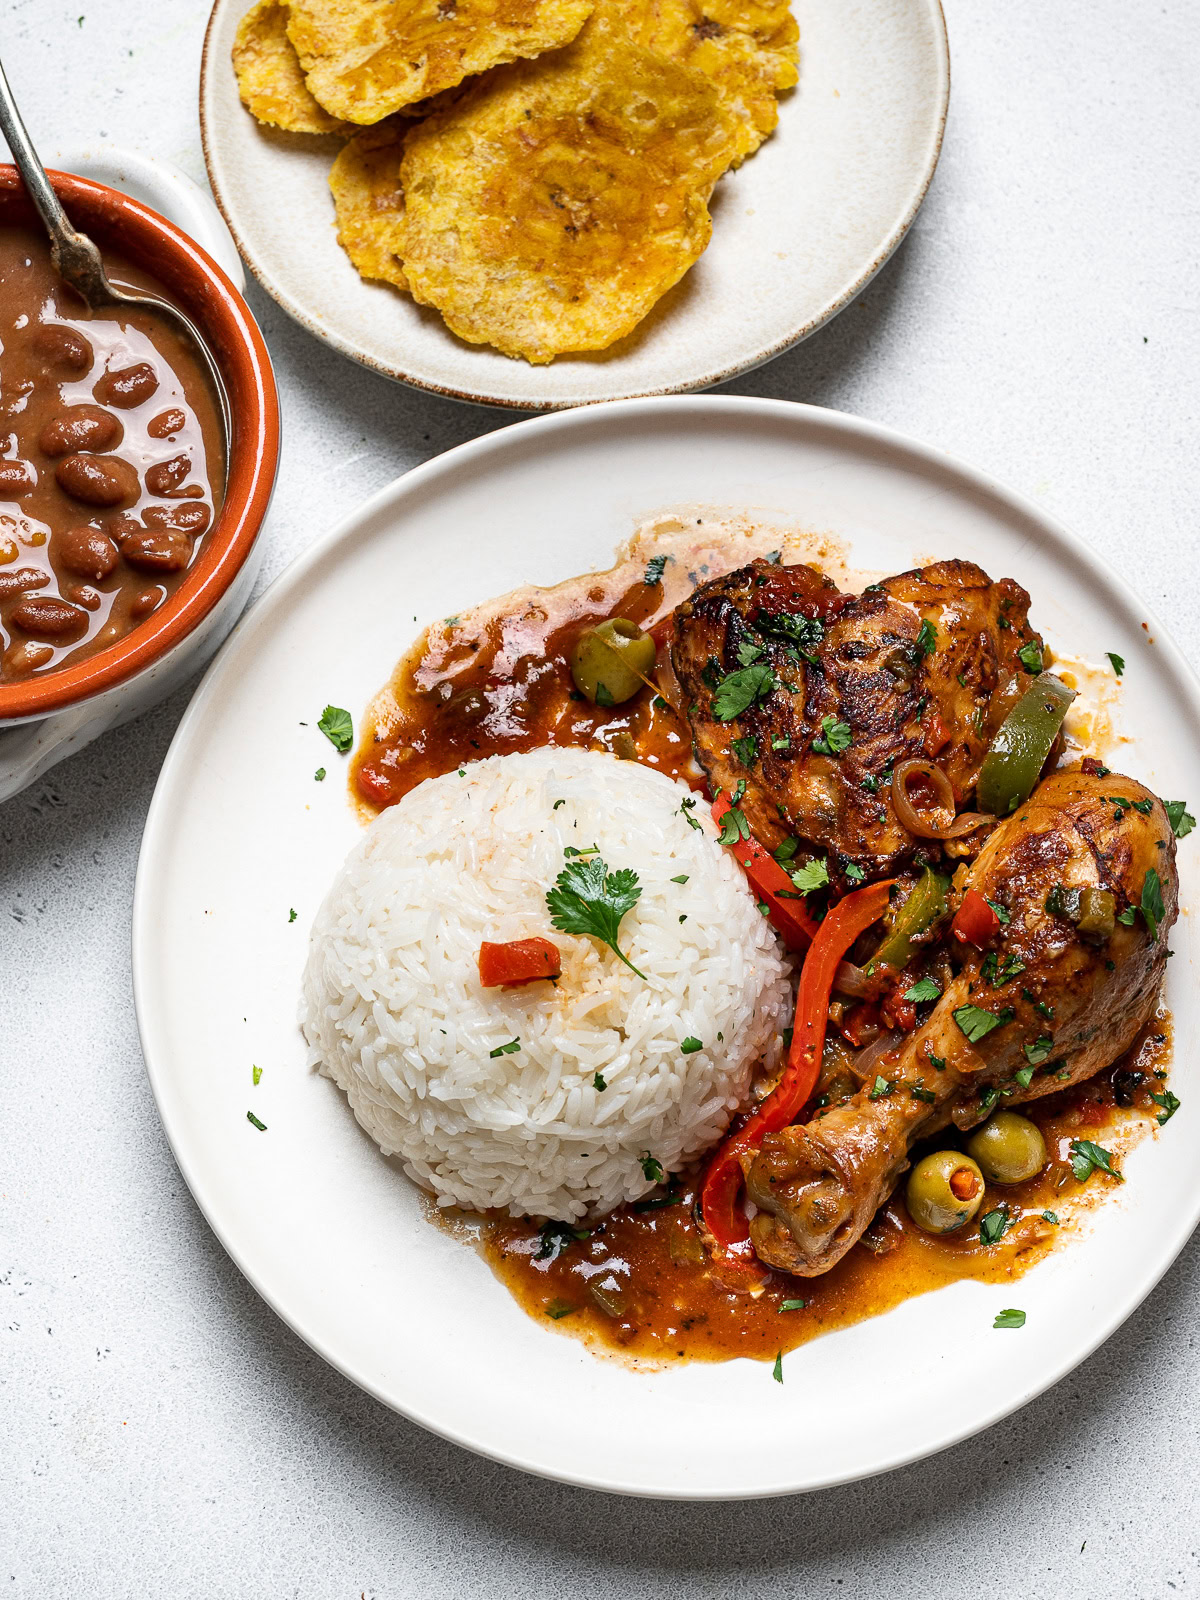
[699,878,894,1275]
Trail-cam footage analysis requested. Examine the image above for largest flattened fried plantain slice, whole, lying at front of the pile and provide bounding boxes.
[397,5,738,365]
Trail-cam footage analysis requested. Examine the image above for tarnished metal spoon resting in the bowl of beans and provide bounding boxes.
[0,62,234,472]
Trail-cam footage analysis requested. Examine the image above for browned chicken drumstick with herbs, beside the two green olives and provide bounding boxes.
[746,768,1178,1277]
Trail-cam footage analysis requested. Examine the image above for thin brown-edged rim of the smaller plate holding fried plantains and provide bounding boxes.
[198,0,950,413]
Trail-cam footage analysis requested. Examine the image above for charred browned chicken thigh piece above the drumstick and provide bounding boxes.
[670,560,1042,890]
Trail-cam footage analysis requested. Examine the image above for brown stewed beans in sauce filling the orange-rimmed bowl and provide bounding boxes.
[0,224,222,681]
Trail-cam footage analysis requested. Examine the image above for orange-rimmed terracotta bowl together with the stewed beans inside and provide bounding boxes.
[0,165,278,798]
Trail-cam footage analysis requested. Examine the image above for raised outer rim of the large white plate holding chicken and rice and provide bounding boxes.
[130,395,1200,1504]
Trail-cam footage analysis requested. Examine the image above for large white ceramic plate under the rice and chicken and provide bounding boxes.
[133,397,1200,1498]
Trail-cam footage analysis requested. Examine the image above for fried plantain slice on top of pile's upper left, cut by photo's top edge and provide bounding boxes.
[288,0,592,125]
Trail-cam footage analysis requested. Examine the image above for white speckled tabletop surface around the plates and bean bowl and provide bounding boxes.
[0,0,1200,1600]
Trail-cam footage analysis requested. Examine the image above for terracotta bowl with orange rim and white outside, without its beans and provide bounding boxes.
[0,165,280,798]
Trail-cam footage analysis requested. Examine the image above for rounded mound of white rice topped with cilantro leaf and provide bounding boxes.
[302,749,790,1221]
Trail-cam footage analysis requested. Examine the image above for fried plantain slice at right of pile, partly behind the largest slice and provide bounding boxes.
[627,0,800,165]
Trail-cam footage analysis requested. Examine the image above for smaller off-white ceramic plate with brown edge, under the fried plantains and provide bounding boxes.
[200,0,950,410]
